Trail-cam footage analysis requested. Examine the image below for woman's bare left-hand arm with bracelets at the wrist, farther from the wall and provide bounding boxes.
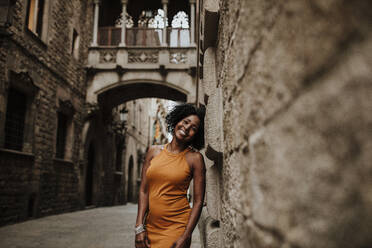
[135,146,157,248]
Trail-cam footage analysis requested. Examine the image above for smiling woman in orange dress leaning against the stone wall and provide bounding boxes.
[135,104,205,248]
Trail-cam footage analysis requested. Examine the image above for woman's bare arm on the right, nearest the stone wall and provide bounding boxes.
[171,152,206,248]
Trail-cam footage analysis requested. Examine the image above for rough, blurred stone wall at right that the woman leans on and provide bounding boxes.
[201,0,372,248]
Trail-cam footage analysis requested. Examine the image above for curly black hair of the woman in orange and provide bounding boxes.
[165,103,205,150]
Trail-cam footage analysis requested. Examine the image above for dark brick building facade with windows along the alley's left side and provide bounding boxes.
[0,0,92,224]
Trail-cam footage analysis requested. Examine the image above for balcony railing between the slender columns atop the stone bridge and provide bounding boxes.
[98,27,190,47]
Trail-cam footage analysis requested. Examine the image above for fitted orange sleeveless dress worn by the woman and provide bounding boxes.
[146,145,192,248]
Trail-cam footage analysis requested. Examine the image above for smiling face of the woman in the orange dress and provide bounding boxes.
[174,115,200,143]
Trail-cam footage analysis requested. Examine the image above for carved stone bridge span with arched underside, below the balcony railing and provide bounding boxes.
[87,47,196,108]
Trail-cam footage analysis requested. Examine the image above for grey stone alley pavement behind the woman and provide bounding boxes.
[0,203,201,248]
